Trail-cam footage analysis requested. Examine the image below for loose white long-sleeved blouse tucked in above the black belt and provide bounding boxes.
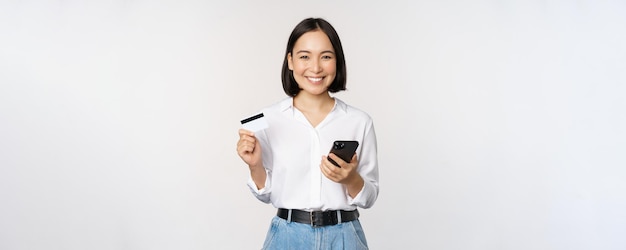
[248,98,378,211]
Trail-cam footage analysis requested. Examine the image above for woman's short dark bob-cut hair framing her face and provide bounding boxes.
[281,18,347,97]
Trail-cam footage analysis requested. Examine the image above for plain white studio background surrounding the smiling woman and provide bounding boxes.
[0,0,626,250]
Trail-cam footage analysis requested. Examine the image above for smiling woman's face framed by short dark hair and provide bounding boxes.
[287,30,337,95]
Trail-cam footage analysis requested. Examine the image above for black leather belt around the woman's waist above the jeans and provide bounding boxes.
[276,208,359,227]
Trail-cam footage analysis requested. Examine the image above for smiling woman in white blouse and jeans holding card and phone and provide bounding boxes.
[237,18,378,249]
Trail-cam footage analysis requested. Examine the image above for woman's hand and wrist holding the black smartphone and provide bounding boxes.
[320,153,364,198]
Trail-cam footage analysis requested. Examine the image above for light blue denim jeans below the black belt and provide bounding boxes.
[263,216,368,250]
